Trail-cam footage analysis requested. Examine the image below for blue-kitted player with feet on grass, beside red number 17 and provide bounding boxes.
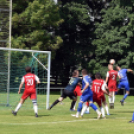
[72,69,101,119]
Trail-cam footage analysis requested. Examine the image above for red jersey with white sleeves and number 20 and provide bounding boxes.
[21,73,39,91]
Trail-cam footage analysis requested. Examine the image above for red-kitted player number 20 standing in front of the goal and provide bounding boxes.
[12,67,40,117]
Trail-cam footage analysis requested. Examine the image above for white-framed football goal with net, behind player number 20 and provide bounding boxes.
[0,47,51,108]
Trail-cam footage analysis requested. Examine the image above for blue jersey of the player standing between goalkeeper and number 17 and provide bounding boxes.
[82,75,93,95]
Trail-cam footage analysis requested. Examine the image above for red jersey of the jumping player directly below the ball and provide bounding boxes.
[107,70,118,83]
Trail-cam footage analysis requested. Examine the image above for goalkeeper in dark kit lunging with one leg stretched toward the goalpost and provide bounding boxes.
[48,70,82,110]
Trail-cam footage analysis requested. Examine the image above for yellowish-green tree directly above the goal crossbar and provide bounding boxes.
[12,0,63,57]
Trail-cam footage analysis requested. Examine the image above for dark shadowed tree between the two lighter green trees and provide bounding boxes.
[52,0,110,83]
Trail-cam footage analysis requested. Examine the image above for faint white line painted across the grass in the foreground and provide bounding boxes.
[0,117,126,126]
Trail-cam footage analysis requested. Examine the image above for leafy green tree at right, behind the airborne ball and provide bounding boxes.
[93,0,134,77]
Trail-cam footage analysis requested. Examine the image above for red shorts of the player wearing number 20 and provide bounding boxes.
[21,91,37,100]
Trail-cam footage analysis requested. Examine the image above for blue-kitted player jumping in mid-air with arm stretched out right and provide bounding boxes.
[116,66,133,105]
